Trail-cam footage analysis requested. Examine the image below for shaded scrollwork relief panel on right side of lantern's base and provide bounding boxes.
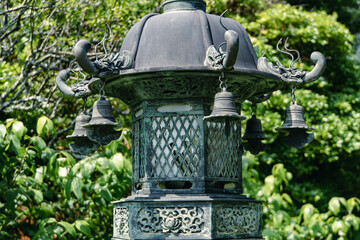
[216,205,261,234]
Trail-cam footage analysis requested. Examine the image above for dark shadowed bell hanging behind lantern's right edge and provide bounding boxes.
[242,114,268,155]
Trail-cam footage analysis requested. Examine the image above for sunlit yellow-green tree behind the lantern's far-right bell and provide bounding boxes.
[235,0,360,202]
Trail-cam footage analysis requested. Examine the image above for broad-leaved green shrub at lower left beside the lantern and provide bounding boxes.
[0,116,131,239]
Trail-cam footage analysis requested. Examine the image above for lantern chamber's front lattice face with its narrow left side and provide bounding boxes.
[132,99,204,194]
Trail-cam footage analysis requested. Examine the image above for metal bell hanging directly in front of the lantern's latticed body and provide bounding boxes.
[204,89,246,122]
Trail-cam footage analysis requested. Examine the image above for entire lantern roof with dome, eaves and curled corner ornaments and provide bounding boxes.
[57,0,326,106]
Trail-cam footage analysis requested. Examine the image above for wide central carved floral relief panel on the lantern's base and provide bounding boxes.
[137,207,205,234]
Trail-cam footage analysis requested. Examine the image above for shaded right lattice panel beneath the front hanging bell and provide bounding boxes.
[206,122,242,178]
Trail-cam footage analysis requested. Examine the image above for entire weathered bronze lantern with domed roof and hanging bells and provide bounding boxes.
[56,0,325,240]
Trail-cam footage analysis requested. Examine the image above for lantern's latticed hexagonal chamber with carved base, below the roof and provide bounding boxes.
[113,99,262,240]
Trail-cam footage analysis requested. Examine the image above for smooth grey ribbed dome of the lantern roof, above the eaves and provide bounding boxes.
[121,1,257,71]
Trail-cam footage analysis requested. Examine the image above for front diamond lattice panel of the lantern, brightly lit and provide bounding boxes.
[150,115,200,177]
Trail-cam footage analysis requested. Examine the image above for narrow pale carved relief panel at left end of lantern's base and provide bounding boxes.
[114,207,129,238]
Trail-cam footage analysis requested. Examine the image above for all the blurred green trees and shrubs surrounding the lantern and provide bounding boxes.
[0,0,360,240]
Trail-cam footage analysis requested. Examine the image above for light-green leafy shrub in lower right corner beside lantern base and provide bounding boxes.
[244,157,360,240]
